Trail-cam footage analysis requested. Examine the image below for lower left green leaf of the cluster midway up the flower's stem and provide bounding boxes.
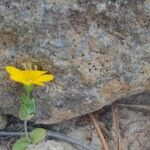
[19,104,34,120]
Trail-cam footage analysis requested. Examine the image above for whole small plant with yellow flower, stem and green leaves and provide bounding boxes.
[6,66,54,150]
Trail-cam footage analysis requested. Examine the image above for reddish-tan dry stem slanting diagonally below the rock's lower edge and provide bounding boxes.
[89,114,109,150]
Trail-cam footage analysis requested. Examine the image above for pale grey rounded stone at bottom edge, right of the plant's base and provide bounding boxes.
[27,141,77,150]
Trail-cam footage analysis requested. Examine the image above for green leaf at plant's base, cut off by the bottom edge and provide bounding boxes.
[12,137,32,150]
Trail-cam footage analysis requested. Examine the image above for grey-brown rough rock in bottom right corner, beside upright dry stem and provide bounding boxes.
[116,108,150,150]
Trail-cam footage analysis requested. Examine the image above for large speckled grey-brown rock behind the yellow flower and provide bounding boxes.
[0,0,150,124]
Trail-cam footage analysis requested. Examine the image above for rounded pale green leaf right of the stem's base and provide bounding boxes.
[30,128,47,144]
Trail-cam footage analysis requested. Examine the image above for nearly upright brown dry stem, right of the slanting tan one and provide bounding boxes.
[112,105,123,150]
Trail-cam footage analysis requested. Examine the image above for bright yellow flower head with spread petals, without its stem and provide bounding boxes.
[6,66,54,85]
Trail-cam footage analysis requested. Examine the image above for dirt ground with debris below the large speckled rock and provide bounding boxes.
[0,93,150,150]
